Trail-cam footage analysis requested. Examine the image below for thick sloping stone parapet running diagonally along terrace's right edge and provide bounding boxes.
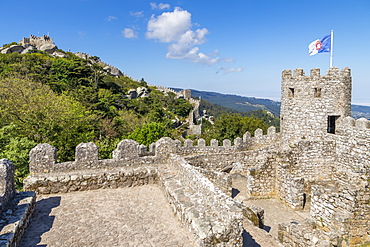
[160,155,243,246]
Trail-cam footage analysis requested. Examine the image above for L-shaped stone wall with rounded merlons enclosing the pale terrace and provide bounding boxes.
[24,138,246,246]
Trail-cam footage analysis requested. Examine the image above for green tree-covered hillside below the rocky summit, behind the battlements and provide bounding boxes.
[0,44,273,188]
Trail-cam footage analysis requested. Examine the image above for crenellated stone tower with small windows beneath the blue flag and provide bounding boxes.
[280,67,352,142]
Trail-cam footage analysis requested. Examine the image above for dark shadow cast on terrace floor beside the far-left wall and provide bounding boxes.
[20,196,61,247]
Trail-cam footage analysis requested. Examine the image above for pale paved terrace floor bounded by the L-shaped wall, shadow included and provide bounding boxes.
[20,185,195,247]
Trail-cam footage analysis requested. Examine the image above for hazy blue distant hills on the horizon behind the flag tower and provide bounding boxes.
[173,88,370,120]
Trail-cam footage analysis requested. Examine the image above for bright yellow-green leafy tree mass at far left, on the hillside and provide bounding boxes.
[0,78,96,160]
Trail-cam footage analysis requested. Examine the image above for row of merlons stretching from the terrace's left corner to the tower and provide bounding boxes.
[29,127,280,174]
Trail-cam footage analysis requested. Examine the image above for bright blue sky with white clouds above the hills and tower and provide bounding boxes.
[0,0,370,105]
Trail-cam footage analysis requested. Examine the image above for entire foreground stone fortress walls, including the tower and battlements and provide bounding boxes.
[1,68,370,246]
